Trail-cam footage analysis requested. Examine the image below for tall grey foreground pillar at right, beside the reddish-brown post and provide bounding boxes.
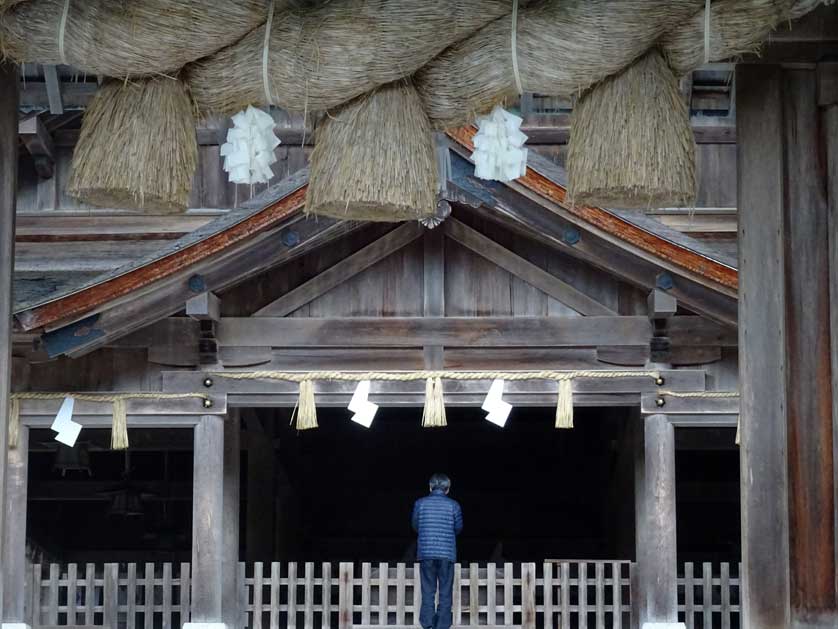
[736,65,791,629]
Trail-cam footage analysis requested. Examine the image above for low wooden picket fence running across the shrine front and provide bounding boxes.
[28,561,739,629]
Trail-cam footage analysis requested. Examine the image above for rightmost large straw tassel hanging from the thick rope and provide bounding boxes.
[567,50,696,209]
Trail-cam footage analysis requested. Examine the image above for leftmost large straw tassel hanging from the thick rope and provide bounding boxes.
[67,78,198,212]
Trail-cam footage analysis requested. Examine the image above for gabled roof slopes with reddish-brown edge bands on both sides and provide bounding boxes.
[15,128,737,344]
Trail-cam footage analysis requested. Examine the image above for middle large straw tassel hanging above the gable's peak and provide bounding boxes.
[306,81,437,222]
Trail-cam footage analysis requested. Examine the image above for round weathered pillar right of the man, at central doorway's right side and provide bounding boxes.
[636,415,678,626]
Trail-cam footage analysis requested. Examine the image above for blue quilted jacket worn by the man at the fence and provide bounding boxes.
[412,490,463,561]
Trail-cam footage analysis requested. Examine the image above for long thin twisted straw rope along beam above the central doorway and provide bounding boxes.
[209,370,660,382]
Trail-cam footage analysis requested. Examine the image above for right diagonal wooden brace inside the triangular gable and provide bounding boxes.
[443,218,617,315]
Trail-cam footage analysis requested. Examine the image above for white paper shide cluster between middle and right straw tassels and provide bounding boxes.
[471,105,527,181]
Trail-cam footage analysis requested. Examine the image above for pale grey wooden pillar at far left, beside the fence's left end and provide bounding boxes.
[2,426,29,623]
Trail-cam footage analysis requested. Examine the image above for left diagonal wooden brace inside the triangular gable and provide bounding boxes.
[253,222,422,317]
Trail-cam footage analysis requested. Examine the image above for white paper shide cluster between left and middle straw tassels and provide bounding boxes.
[221,107,281,184]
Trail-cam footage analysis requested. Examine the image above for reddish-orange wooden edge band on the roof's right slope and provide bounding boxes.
[448,127,738,289]
